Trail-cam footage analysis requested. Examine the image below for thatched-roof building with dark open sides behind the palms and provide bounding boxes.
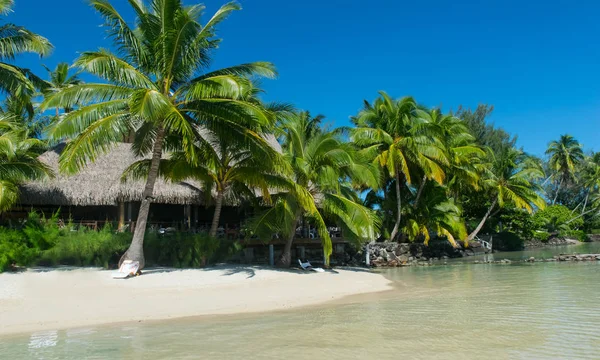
[6,143,244,228]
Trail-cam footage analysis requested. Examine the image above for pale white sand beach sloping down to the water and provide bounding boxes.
[0,266,391,335]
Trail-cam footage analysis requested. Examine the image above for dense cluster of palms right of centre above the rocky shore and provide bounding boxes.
[351,92,544,246]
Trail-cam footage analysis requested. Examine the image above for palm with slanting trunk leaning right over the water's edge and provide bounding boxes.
[467,148,546,241]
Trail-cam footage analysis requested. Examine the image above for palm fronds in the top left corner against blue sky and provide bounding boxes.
[0,0,52,114]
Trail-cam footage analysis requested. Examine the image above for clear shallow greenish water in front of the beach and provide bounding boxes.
[0,244,600,360]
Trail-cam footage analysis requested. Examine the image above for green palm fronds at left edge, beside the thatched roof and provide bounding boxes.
[0,114,52,213]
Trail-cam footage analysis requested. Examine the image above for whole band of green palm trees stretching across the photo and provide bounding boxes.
[0,0,600,267]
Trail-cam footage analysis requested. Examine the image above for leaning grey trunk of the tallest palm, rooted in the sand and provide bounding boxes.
[119,127,165,270]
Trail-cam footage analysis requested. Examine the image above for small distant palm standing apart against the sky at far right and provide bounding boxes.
[546,134,584,205]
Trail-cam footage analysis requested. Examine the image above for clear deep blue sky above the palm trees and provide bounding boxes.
[8,0,600,155]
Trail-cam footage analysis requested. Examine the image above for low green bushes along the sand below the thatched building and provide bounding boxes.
[0,212,240,272]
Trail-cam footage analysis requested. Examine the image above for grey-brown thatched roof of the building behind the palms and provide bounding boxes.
[20,143,203,206]
